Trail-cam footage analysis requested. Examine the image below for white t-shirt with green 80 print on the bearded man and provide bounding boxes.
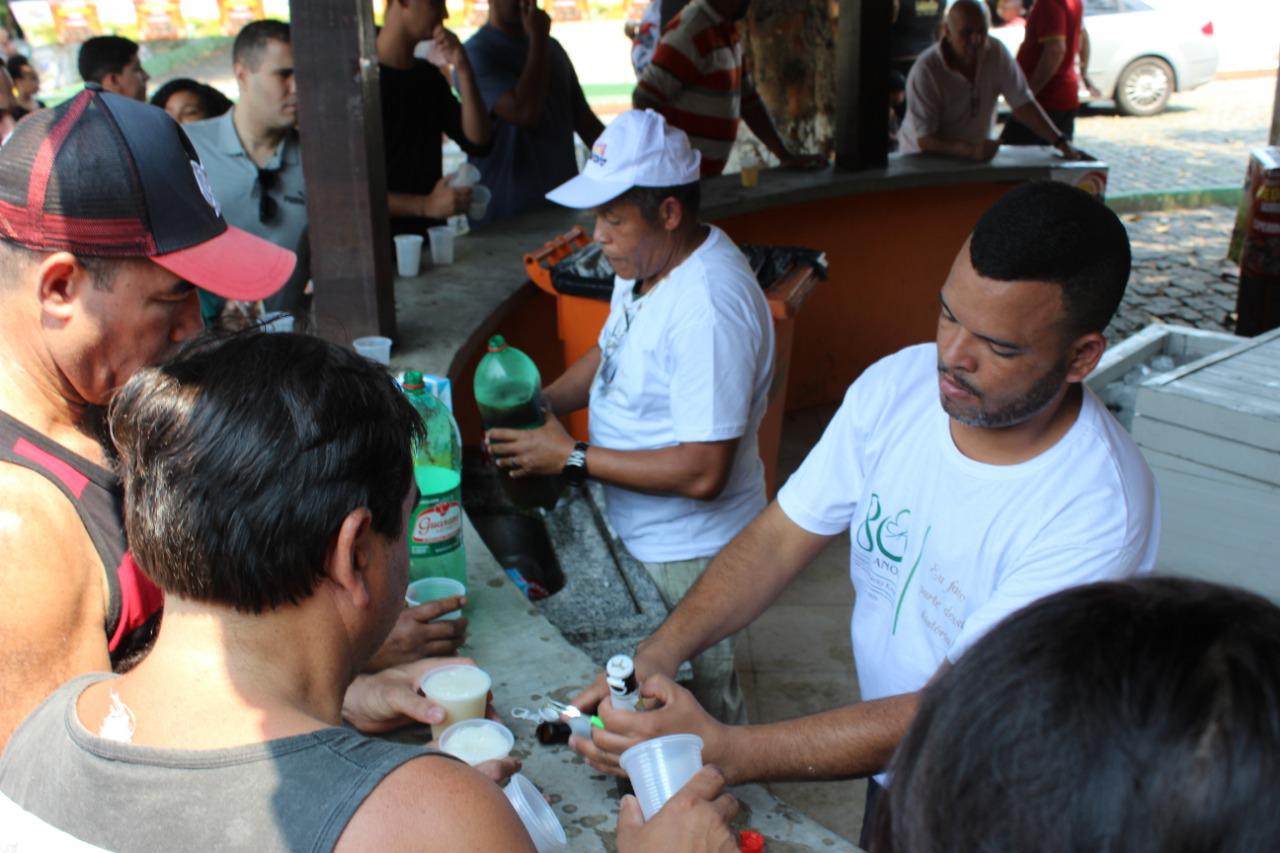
[778,343,1160,773]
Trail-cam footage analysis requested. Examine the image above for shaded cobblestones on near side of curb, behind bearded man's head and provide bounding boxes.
[1107,207,1239,345]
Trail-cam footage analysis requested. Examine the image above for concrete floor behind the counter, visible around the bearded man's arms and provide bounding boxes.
[737,406,865,841]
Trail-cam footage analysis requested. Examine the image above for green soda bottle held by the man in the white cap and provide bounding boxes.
[475,334,563,510]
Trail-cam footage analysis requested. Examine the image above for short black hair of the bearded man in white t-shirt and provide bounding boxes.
[969,181,1130,337]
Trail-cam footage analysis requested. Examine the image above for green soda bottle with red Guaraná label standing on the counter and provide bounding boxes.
[404,370,467,584]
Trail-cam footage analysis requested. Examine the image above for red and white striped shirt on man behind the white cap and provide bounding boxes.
[634,0,759,178]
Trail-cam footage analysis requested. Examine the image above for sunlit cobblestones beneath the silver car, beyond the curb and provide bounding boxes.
[1075,76,1276,196]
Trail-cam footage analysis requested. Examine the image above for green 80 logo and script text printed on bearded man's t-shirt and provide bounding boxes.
[852,492,965,646]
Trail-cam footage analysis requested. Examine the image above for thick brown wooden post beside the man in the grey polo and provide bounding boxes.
[289,0,396,342]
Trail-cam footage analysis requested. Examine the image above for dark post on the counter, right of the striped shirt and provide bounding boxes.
[836,0,892,169]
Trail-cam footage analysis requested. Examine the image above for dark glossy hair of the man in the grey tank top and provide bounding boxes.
[109,333,422,613]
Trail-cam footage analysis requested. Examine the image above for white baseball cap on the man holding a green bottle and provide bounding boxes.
[547,110,703,209]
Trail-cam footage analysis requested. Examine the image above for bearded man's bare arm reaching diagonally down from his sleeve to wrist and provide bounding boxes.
[636,501,831,678]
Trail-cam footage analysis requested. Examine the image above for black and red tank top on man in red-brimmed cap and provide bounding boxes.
[0,411,164,671]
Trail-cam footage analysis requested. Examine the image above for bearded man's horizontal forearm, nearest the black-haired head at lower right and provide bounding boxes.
[708,693,920,785]
